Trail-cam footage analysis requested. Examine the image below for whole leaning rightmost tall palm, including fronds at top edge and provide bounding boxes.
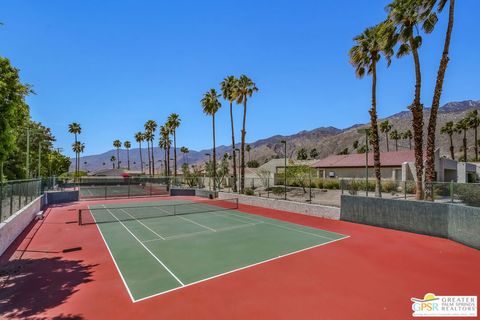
[423,0,455,184]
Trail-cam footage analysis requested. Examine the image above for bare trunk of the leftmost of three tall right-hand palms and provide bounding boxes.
[365,62,380,197]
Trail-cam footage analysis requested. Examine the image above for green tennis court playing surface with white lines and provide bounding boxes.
[85,199,346,301]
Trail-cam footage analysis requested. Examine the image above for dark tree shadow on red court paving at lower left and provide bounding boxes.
[0,257,97,319]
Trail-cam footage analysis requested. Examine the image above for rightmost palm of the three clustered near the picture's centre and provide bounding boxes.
[235,75,258,193]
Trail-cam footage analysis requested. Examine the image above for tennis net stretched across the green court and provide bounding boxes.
[78,198,238,225]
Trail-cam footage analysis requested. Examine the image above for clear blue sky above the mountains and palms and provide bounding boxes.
[0,0,480,155]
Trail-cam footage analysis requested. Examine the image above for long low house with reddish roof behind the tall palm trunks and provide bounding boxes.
[312,149,478,182]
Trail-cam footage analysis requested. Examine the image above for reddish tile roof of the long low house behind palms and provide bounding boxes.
[312,150,415,168]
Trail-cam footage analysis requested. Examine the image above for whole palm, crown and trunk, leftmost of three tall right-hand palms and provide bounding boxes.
[349,21,394,197]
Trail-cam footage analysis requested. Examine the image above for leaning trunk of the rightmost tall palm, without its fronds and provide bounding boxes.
[425,0,455,185]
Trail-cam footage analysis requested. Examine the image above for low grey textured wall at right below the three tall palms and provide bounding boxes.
[340,195,480,249]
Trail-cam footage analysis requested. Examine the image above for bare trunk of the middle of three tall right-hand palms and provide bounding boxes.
[410,37,423,200]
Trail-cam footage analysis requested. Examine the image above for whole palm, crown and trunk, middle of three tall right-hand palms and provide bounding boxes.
[387,0,425,200]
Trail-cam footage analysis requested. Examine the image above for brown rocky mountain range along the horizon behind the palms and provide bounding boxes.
[70,100,480,172]
